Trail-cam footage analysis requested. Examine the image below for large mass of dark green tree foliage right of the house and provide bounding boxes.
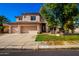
[40,3,79,33]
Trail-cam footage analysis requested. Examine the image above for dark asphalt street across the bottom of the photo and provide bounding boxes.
[0,49,79,56]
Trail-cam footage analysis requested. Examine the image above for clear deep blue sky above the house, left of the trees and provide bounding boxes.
[0,3,43,22]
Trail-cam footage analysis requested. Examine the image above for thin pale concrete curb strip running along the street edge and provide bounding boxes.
[0,45,79,50]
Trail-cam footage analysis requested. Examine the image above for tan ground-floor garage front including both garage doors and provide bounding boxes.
[11,23,41,33]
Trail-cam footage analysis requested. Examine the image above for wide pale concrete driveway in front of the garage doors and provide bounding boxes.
[0,33,36,49]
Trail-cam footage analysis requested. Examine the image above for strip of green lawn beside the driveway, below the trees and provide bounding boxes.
[36,34,79,41]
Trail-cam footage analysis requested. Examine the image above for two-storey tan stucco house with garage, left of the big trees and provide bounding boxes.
[4,13,48,33]
